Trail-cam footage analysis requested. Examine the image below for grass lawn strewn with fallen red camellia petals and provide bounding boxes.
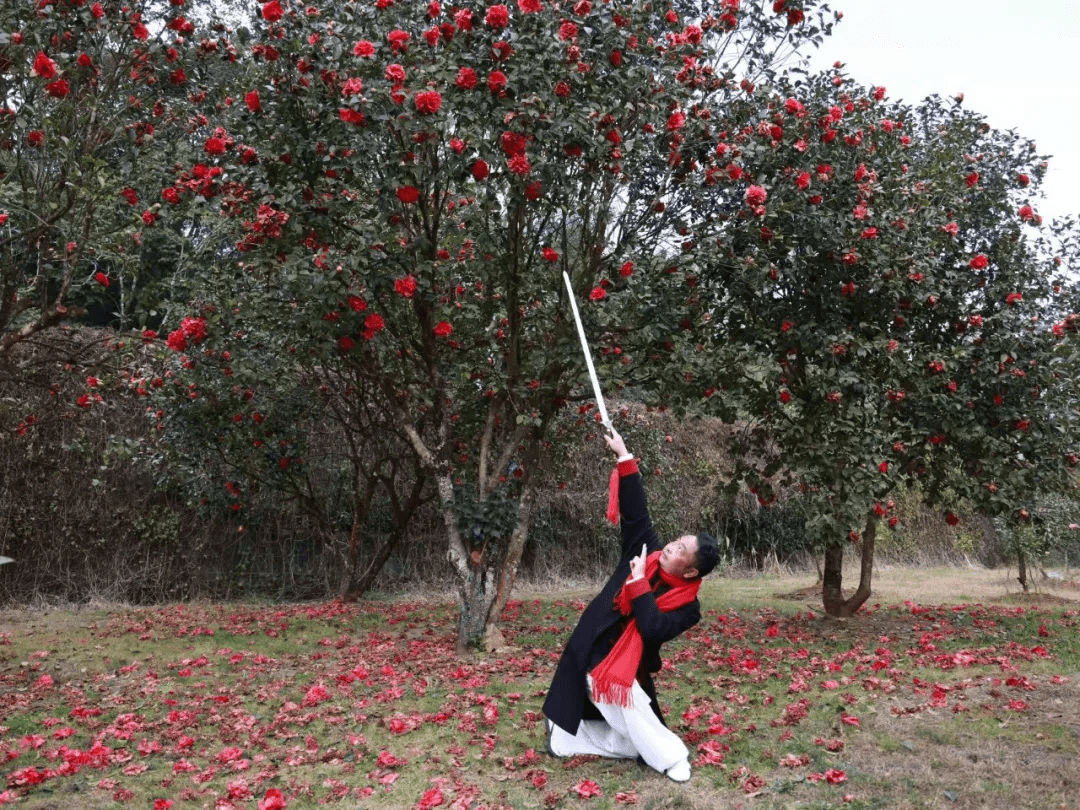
[0,569,1080,810]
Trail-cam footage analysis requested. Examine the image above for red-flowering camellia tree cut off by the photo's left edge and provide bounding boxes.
[0,0,236,428]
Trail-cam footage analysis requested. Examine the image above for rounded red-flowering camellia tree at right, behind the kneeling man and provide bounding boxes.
[615,69,1077,616]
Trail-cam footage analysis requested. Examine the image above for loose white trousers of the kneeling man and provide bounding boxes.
[551,675,689,773]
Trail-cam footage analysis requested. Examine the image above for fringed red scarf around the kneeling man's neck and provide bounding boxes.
[589,551,701,708]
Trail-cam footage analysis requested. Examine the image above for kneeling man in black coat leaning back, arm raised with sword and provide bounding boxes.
[543,432,719,782]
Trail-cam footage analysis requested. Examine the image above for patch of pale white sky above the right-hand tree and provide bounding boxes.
[811,0,1080,221]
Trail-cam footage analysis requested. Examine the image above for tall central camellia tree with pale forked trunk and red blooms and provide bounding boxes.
[166,0,842,647]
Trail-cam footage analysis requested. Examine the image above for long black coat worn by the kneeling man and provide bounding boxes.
[543,473,701,734]
